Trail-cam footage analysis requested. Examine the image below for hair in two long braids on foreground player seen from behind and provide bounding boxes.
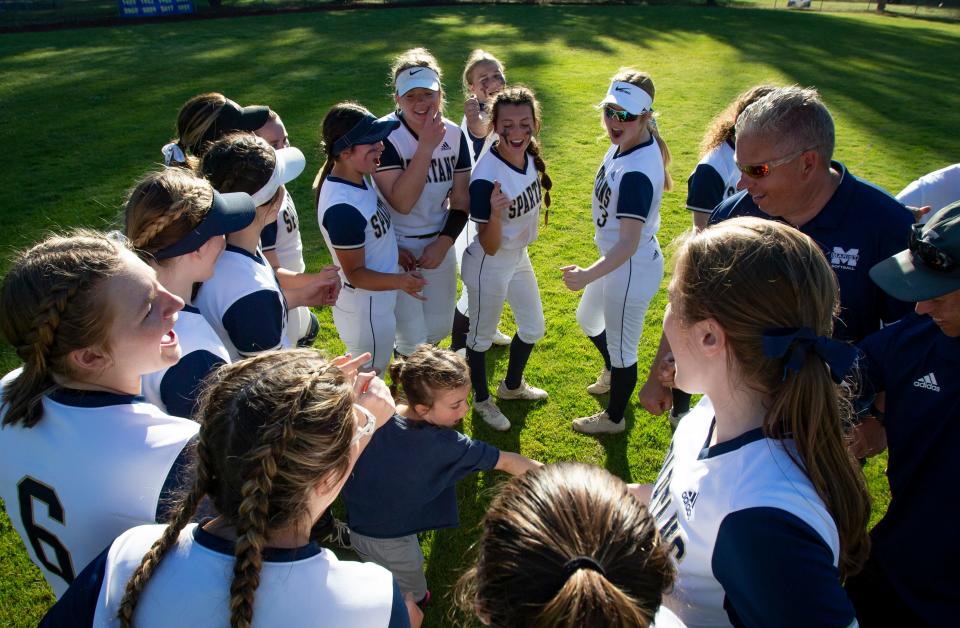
[119,349,354,627]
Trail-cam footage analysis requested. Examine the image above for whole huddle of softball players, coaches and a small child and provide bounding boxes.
[0,48,960,628]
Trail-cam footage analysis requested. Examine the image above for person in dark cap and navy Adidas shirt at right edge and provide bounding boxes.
[847,203,960,628]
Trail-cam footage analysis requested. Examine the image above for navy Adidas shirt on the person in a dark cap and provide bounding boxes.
[859,314,960,626]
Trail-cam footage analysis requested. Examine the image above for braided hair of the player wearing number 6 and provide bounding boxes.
[0,230,125,427]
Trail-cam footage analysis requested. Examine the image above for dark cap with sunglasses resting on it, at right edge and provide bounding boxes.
[870,201,960,302]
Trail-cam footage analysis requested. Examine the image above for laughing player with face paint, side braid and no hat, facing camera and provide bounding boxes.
[461,87,553,430]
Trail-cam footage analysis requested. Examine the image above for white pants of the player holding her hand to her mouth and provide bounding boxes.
[397,235,457,355]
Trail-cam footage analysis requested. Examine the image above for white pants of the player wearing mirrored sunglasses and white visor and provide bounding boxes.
[577,238,663,368]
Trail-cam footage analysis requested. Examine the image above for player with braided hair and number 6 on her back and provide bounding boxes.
[0,231,198,597]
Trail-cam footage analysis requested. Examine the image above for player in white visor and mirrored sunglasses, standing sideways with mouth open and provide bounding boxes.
[561,69,671,434]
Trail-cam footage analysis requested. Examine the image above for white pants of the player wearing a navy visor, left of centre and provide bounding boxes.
[333,284,398,375]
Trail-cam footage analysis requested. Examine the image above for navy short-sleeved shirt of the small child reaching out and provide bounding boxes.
[342,415,500,539]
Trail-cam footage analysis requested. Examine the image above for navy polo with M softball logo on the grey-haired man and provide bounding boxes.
[709,161,913,342]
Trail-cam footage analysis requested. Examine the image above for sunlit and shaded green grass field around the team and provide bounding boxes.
[0,6,960,626]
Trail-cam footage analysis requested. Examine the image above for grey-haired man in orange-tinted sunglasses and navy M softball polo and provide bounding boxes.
[710,86,913,341]
